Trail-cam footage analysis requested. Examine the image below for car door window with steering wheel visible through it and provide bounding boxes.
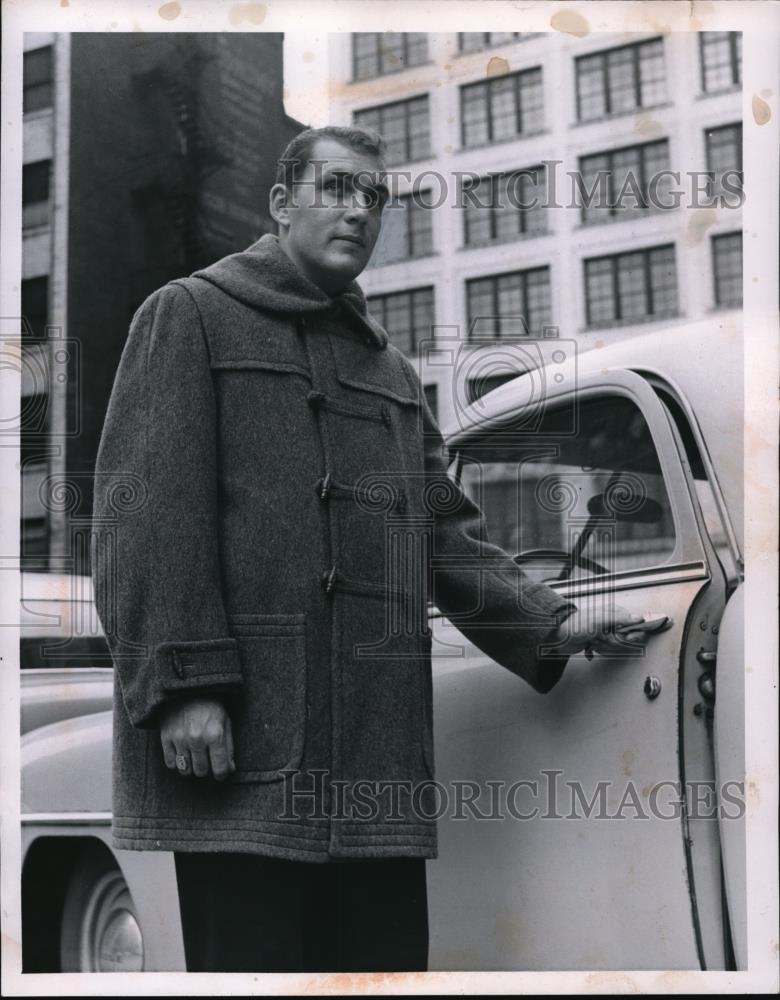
[459,396,675,579]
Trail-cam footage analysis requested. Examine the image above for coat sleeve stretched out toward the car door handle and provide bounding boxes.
[422,372,576,693]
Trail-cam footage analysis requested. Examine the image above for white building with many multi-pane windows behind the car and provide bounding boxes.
[287,32,742,423]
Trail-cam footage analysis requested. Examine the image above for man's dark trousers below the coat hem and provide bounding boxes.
[175,852,428,972]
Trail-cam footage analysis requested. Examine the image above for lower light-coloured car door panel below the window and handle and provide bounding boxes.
[429,580,702,969]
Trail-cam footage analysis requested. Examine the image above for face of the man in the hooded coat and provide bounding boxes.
[271,137,387,295]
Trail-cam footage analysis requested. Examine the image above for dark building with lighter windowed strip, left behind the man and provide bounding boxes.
[21,32,301,570]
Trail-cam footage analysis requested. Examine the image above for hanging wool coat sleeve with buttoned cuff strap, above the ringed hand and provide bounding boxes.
[92,284,242,728]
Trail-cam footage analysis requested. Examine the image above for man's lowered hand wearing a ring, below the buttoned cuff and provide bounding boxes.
[160,698,236,781]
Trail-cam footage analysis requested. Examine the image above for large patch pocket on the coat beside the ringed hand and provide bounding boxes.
[228,615,306,782]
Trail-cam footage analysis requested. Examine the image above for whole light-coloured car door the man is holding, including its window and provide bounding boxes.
[429,371,728,969]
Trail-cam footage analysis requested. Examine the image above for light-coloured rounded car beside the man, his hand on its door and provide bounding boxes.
[21,313,747,971]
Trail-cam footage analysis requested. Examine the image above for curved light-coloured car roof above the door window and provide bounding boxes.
[444,311,744,546]
